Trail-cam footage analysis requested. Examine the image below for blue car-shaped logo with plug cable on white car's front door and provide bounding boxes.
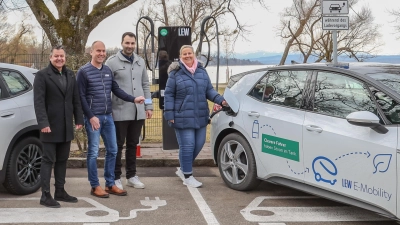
[312,156,338,185]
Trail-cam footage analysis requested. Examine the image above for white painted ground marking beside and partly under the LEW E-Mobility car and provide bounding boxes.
[240,196,389,224]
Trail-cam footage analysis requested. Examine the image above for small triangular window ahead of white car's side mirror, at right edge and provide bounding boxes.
[370,86,400,124]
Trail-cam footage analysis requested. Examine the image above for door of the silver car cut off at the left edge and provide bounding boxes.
[0,68,21,169]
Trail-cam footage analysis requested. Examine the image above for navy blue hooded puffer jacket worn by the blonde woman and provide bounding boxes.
[164,61,224,129]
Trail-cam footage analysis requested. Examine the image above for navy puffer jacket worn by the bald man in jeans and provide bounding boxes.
[76,62,135,119]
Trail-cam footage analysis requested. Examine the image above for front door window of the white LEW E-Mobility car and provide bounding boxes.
[314,72,378,118]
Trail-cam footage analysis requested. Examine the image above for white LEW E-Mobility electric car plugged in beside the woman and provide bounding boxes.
[211,63,400,218]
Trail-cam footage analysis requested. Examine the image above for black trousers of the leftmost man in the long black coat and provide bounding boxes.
[40,141,71,192]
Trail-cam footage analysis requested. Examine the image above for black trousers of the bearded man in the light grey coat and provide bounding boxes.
[114,120,144,180]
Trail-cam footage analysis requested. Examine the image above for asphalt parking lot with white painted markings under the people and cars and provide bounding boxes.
[0,167,397,225]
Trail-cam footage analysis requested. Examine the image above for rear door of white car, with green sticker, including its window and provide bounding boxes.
[240,70,309,182]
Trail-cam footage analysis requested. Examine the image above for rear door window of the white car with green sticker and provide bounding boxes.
[250,70,307,108]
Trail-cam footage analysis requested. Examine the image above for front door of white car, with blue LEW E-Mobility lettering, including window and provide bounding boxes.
[303,71,398,214]
